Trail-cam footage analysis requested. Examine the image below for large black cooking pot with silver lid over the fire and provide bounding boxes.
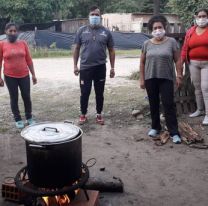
[21,122,83,188]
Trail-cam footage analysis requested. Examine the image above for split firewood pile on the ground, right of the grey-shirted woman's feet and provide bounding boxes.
[178,122,204,145]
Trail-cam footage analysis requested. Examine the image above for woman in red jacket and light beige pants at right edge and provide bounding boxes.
[181,9,208,125]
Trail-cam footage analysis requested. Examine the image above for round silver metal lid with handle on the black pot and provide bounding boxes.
[21,122,80,144]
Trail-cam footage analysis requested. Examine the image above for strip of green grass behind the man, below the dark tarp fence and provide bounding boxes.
[30,48,141,58]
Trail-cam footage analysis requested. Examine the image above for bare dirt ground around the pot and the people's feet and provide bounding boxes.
[0,58,208,206]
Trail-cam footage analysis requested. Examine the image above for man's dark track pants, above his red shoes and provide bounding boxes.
[80,64,106,114]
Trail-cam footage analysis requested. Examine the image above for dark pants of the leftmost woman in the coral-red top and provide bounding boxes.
[5,75,32,121]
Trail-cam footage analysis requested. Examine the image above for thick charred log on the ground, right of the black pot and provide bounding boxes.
[84,177,123,192]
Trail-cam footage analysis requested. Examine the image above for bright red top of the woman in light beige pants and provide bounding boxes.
[188,29,208,61]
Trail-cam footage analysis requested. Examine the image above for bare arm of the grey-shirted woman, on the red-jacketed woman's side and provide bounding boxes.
[173,50,183,87]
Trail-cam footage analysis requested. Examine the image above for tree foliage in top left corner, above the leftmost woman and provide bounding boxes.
[0,0,73,23]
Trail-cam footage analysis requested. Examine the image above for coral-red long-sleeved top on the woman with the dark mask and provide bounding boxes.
[0,40,33,78]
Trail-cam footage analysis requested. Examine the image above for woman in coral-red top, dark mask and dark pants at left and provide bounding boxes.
[0,23,37,129]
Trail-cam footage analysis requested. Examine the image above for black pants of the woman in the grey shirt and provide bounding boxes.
[145,78,179,136]
